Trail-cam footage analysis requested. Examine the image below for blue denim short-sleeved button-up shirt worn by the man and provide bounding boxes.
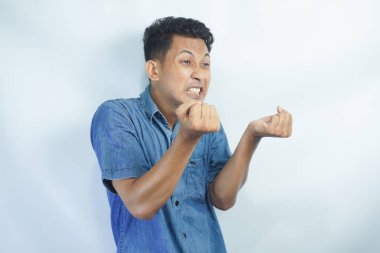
[91,86,231,253]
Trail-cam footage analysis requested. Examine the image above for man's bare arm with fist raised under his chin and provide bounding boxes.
[112,102,220,219]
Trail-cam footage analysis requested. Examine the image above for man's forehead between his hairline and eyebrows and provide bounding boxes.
[168,35,209,56]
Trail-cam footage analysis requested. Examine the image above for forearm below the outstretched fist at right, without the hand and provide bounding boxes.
[209,124,260,210]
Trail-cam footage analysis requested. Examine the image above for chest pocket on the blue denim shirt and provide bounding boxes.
[186,158,207,202]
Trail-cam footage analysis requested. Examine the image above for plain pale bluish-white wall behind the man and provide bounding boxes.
[0,0,380,253]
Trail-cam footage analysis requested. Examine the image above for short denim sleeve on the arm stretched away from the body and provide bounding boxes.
[207,125,231,183]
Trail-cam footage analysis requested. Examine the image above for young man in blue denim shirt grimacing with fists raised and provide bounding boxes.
[91,17,292,253]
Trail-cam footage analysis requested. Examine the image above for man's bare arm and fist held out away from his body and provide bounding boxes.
[208,107,292,210]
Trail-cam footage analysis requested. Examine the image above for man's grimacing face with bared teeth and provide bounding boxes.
[154,35,211,109]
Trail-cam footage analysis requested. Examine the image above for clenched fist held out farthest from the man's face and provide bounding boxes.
[249,106,293,138]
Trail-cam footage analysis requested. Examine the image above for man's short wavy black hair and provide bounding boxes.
[143,17,214,61]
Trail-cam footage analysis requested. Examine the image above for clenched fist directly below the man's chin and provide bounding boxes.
[175,101,220,140]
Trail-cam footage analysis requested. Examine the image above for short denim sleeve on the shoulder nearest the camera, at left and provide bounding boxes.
[91,101,149,193]
